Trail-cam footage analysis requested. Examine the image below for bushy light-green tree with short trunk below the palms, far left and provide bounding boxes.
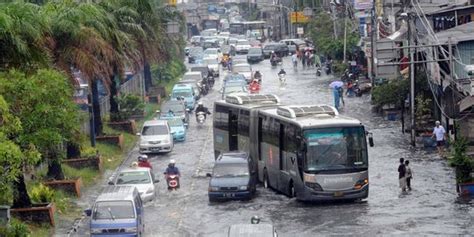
[0,69,79,187]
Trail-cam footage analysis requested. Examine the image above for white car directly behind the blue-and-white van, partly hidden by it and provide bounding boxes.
[109,167,158,202]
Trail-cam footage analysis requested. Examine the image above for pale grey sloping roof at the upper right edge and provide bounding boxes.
[436,22,474,44]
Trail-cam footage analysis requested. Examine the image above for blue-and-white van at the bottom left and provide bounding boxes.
[85,186,145,237]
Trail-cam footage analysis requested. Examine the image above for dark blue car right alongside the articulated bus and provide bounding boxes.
[207,152,257,202]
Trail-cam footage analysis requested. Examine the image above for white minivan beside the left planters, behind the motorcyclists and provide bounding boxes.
[137,120,174,153]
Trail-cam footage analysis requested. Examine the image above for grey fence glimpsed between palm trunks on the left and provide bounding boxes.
[81,72,145,135]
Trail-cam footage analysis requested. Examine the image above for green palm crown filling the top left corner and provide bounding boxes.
[0,2,50,71]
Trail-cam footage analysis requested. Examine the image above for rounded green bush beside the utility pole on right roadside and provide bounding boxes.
[372,79,410,107]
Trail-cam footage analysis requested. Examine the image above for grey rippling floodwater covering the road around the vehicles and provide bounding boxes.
[64,57,474,236]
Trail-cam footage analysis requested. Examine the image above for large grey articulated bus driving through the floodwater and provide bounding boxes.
[214,96,369,201]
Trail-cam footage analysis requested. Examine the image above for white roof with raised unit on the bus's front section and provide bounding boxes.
[260,105,361,127]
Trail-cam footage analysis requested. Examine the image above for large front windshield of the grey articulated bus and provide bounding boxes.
[304,127,368,172]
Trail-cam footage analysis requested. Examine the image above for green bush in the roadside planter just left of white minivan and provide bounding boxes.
[111,94,145,121]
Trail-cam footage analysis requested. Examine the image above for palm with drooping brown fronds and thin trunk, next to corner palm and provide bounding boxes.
[44,1,117,135]
